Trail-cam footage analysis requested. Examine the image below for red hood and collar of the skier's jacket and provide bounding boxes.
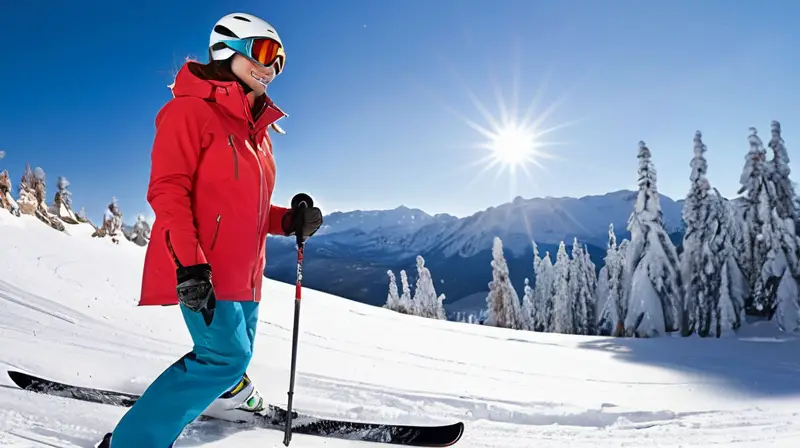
[169,61,286,130]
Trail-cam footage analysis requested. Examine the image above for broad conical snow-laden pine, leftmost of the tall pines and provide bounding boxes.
[625,141,683,337]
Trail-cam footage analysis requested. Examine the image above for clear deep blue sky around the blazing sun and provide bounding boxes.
[0,0,800,221]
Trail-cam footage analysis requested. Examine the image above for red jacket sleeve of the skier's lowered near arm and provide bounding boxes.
[147,98,210,267]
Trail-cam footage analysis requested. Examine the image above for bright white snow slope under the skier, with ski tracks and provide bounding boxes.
[0,212,800,448]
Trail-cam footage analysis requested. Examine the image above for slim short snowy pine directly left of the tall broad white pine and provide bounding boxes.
[597,224,627,337]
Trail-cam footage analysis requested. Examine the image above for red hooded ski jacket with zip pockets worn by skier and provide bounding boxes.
[139,62,286,305]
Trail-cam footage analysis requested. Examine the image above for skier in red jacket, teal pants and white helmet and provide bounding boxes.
[97,13,322,448]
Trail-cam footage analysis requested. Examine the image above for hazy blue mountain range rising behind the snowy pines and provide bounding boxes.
[265,190,683,314]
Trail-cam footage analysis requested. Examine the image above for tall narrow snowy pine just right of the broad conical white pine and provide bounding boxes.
[680,131,726,337]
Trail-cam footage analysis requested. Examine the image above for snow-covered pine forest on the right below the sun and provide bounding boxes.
[387,121,800,337]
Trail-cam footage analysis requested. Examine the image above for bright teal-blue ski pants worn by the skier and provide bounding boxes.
[111,301,258,448]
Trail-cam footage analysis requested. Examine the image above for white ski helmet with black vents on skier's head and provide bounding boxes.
[208,12,285,65]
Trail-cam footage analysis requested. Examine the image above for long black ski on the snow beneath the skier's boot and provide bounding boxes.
[8,370,464,447]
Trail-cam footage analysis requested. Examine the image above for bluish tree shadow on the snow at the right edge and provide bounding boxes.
[580,326,800,397]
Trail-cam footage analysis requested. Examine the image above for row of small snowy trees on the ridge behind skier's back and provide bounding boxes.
[0,158,150,246]
